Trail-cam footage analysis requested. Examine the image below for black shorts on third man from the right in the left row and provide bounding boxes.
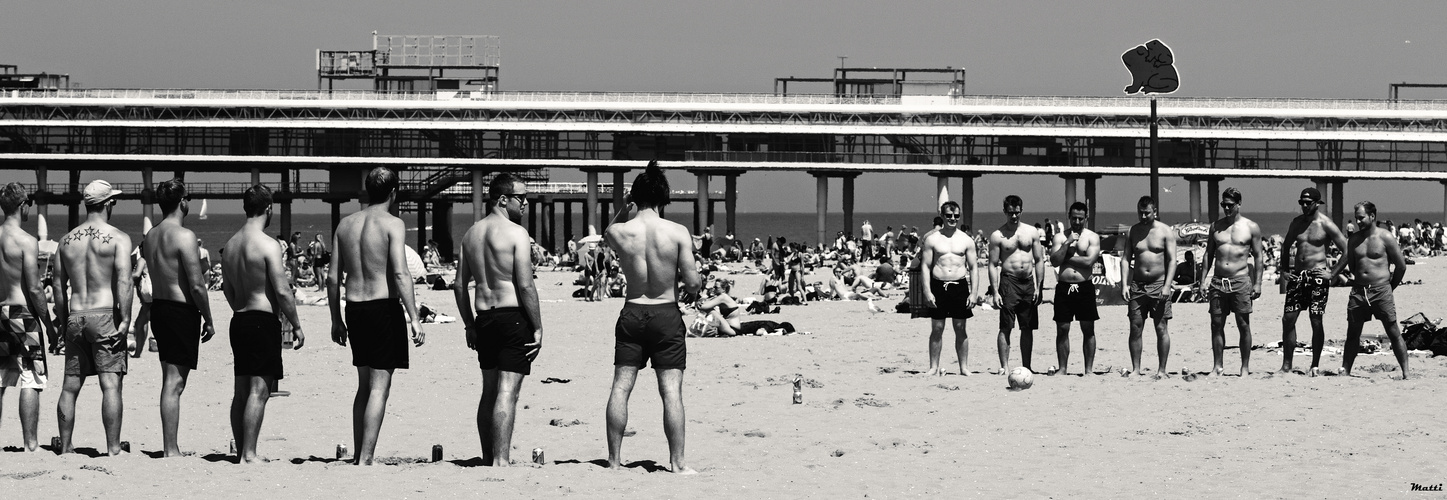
[346,298,408,370]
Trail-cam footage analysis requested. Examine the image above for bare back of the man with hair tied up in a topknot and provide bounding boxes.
[603,210,699,303]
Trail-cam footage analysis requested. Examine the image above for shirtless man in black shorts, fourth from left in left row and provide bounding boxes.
[221,184,307,464]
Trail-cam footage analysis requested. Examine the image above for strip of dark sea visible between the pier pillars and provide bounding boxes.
[25,207,1441,249]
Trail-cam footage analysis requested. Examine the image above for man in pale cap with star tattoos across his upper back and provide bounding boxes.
[55,181,132,455]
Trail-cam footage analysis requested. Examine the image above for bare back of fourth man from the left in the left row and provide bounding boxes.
[221,228,285,312]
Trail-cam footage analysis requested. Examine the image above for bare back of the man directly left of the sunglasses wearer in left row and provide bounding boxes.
[333,205,407,302]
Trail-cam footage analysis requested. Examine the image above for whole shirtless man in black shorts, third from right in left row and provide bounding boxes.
[327,166,425,465]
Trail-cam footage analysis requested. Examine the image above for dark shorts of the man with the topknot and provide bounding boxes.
[614,302,689,370]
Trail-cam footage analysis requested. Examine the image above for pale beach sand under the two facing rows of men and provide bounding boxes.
[0,259,1447,499]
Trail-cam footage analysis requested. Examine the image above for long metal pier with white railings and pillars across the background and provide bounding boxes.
[0,90,1447,248]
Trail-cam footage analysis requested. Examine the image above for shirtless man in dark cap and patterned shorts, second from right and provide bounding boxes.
[1279,188,1347,377]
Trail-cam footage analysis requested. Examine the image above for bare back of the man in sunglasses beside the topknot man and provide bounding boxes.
[457,214,532,311]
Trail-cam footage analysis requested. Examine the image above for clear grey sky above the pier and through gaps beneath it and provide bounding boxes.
[0,0,1447,211]
